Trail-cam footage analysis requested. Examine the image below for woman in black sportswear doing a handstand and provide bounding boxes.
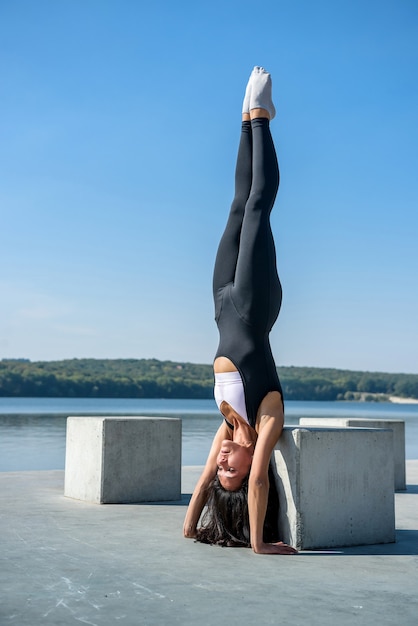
[183,67,296,554]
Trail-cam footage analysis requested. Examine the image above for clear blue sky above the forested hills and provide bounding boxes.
[0,0,418,373]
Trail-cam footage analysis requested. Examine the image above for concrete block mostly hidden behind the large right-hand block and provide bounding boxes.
[299,417,406,491]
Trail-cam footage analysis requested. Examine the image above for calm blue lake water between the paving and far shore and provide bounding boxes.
[0,398,418,472]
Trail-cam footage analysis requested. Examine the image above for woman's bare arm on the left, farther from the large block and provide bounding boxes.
[183,421,232,537]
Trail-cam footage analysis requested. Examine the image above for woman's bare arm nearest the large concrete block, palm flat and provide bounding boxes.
[248,392,297,554]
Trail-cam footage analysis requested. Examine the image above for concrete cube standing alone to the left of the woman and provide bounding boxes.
[64,416,181,504]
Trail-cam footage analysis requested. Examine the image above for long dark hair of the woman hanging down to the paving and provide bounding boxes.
[196,466,279,548]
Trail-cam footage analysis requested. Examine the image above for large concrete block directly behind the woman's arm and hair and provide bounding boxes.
[274,426,395,549]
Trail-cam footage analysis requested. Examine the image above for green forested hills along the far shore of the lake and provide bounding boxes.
[0,359,418,401]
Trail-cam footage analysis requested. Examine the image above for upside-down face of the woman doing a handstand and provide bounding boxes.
[216,439,254,491]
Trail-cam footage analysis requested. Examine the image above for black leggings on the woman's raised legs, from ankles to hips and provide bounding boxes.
[213,118,282,332]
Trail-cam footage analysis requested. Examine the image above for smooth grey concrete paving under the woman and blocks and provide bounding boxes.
[0,461,418,626]
